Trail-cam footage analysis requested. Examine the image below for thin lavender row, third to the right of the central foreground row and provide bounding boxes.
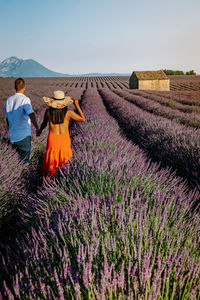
[129,90,200,114]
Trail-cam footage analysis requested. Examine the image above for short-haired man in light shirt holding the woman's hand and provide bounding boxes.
[5,78,38,163]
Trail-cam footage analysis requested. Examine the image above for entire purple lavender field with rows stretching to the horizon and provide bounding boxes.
[0,76,200,300]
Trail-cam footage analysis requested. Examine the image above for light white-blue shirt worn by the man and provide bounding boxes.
[5,93,34,142]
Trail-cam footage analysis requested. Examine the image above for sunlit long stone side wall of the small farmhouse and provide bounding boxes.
[138,79,170,91]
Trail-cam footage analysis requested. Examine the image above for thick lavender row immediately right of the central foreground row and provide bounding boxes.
[100,89,200,186]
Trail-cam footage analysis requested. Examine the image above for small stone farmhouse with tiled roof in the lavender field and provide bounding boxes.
[129,70,170,91]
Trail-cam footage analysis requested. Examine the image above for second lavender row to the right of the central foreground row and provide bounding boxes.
[112,90,200,128]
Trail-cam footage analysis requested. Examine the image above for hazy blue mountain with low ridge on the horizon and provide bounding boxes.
[0,56,131,77]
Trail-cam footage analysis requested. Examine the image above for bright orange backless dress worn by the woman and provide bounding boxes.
[42,129,73,176]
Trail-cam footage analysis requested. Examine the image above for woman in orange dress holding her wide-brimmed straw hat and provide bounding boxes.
[37,91,85,176]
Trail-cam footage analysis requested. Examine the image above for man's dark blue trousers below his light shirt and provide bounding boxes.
[12,136,31,163]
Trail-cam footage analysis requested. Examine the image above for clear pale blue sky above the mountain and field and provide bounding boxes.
[0,0,200,74]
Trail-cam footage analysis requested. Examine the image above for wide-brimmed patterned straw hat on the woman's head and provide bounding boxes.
[43,91,74,108]
